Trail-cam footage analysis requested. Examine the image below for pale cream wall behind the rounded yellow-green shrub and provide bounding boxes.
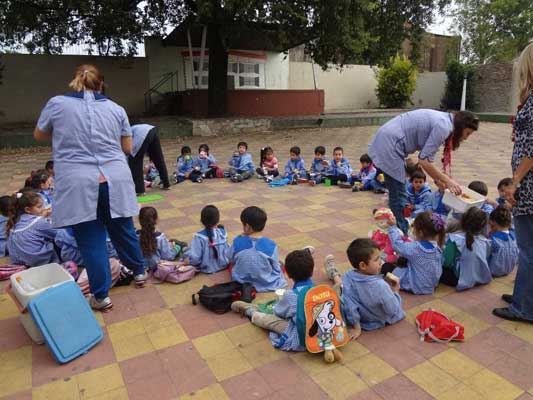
[289,62,446,112]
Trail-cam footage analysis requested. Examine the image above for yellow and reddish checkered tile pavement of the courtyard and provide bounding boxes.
[0,124,533,400]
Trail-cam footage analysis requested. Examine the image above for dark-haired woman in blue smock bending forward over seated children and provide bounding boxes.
[368,109,479,233]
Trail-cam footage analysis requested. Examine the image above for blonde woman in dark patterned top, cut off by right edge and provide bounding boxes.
[493,43,533,323]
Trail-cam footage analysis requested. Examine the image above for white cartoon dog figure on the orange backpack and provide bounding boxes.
[309,300,344,362]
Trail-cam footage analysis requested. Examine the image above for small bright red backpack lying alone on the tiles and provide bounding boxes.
[415,309,465,343]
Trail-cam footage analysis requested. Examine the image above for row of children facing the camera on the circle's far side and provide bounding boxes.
[168,142,385,193]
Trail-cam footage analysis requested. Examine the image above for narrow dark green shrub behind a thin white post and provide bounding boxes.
[441,60,476,110]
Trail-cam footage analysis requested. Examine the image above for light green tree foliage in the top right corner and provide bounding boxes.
[451,0,533,64]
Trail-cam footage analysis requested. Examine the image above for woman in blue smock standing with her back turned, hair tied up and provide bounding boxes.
[34,65,147,311]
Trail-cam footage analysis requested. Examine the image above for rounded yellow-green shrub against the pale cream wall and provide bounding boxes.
[376,55,417,108]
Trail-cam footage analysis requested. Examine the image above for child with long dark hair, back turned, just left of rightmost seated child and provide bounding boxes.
[440,207,492,291]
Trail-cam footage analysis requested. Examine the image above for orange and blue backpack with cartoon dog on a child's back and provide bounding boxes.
[296,285,350,363]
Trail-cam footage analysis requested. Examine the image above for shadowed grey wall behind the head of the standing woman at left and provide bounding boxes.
[0,54,148,124]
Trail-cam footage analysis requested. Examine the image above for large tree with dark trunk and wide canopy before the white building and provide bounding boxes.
[0,0,449,116]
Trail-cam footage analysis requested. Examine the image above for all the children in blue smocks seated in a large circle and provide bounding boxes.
[0,150,518,356]
